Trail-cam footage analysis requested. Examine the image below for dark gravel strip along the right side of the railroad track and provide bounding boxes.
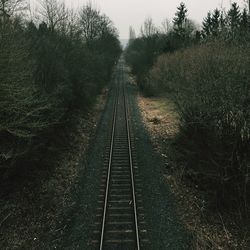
[128,81,190,250]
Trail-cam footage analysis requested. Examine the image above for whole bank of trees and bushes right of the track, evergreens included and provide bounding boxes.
[126,3,250,218]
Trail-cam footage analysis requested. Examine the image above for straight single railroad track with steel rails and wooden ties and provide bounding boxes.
[92,60,149,250]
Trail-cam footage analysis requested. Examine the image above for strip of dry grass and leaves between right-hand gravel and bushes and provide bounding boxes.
[138,96,248,250]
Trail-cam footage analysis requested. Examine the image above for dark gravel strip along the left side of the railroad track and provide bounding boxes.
[61,83,114,250]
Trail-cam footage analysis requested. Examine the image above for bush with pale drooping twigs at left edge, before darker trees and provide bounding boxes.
[0,23,63,164]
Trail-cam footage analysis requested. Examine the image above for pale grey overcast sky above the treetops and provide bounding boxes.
[30,0,244,39]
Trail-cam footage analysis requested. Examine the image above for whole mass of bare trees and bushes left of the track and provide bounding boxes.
[0,0,121,168]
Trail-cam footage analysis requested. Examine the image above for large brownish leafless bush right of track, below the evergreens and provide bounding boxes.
[148,41,250,212]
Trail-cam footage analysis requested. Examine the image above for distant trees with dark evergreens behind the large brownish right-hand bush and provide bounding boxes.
[126,3,250,95]
